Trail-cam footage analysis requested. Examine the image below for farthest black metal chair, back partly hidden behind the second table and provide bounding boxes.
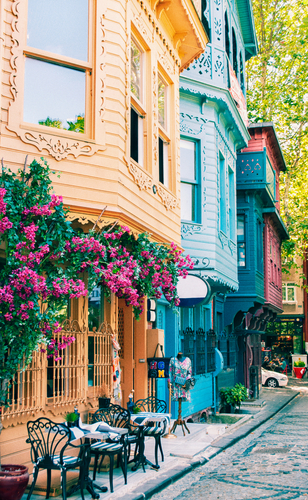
[135,396,167,466]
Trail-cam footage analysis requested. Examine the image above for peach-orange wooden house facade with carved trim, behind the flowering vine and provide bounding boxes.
[0,0,208,464]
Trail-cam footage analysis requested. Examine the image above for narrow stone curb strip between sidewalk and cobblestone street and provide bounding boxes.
[125,391,299,500]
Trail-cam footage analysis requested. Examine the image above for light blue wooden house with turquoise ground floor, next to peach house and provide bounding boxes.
[157,0,257,416]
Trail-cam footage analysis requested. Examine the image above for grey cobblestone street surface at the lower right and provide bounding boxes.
[152,390,308,500]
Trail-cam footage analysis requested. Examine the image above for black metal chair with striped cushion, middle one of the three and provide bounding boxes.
[91,404,137,493]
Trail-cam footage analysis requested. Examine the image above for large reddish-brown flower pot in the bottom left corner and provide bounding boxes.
[0,465,29,500]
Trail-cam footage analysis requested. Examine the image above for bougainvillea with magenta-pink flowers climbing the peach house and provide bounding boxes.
[0,161,193,406]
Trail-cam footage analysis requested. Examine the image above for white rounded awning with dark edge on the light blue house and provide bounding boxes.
[177,274,212,307]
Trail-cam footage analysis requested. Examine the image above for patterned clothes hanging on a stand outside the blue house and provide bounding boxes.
[169,356,192,401]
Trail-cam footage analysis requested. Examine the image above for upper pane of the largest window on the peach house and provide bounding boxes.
[27,0,88,61]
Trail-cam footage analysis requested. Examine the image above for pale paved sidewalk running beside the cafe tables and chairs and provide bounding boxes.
[22,386,298,500]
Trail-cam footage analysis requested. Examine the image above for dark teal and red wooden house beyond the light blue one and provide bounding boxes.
[224,123,288,395]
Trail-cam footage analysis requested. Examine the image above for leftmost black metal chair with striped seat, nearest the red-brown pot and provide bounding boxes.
[26,417,86,500]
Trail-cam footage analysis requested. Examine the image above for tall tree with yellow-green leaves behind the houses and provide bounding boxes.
[247,0,308,266]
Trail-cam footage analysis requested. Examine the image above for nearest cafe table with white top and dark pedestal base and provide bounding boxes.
[68,419,128,500]
